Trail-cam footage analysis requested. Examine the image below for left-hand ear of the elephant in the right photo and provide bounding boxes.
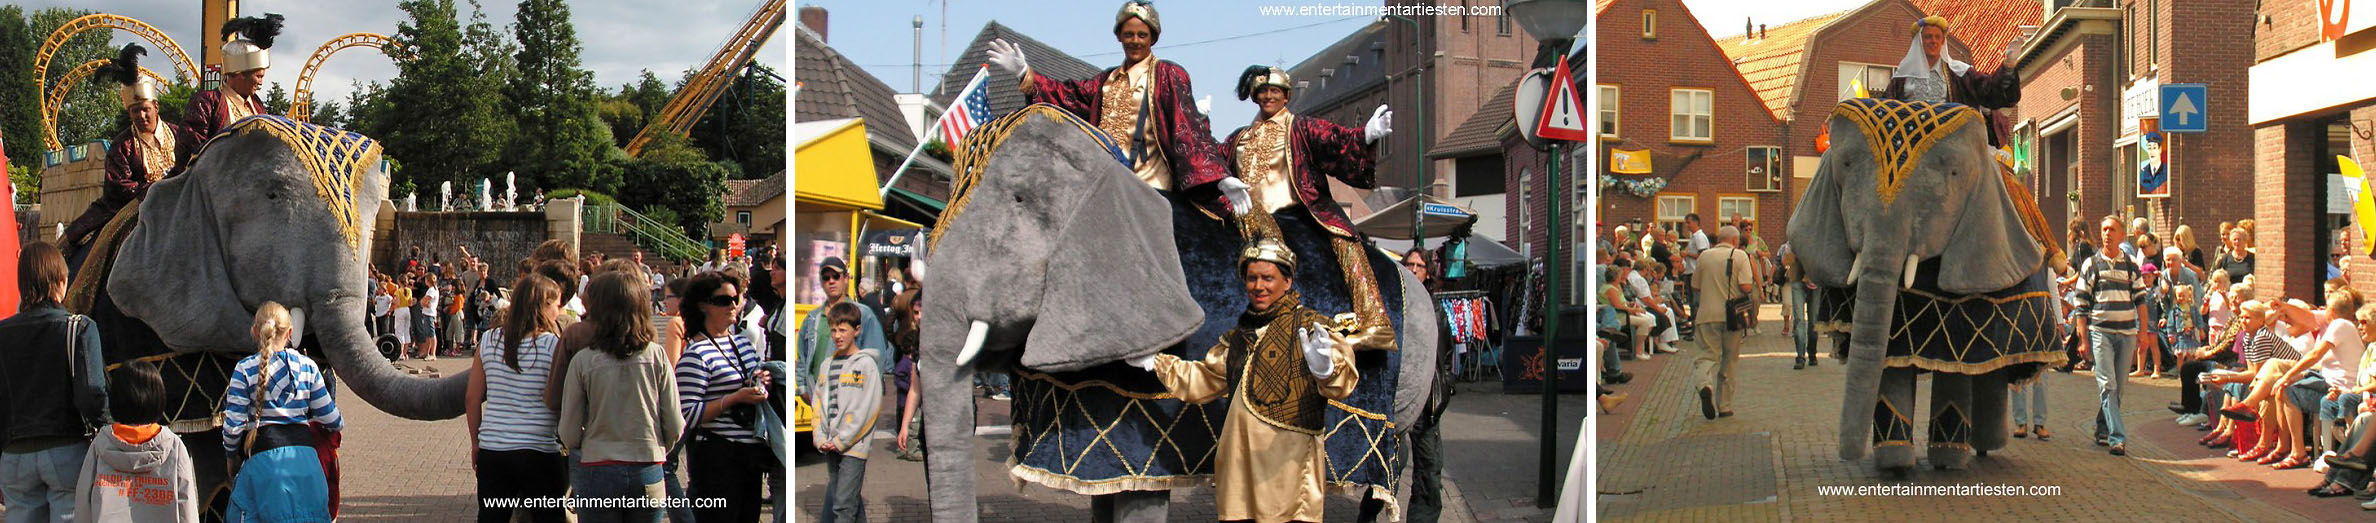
[1789,126,1865,288]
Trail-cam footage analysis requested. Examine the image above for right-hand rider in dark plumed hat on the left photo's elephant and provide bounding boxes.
[181,14,280,145]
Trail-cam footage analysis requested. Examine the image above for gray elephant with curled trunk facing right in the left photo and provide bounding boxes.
[69,116,453,515]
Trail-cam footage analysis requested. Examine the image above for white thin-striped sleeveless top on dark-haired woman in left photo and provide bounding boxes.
[478,328,561,454]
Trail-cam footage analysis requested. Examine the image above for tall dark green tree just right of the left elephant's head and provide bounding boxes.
[382,0,508,188]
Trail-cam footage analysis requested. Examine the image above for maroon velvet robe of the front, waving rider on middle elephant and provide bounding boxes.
[1024,59,1231,216]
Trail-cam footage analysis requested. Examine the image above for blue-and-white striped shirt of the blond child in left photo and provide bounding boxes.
[223,349,347,452]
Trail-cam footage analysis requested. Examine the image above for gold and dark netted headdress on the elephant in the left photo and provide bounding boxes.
[207,114,380,250]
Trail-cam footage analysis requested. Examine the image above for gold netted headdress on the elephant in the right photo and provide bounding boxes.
[1832,97,1979,207]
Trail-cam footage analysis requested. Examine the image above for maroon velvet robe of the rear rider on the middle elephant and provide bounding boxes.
[1228,114,1378,238]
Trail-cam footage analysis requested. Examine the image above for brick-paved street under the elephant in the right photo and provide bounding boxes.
[1594,307,2369,521]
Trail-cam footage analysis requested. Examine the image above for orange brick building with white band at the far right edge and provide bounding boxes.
[2243,0,2376,302]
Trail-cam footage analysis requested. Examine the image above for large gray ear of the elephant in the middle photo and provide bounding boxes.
[1022,152,1205,371]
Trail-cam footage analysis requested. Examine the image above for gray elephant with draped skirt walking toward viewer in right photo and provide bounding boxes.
[1789,100,2065,475]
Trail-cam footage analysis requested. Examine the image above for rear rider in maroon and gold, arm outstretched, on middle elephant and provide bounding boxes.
[1221,64,1395,349]
